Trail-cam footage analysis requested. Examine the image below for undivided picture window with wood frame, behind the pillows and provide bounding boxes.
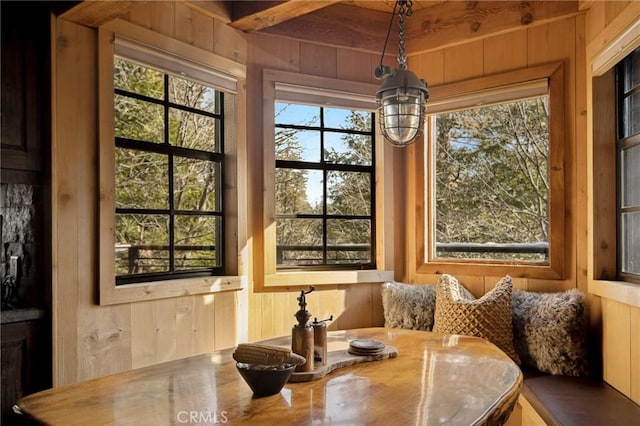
[418,64,565,278]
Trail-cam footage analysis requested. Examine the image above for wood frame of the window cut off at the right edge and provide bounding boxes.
[587,13,640,307]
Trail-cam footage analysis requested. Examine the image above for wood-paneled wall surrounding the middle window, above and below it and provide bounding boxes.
[242,34,384,340]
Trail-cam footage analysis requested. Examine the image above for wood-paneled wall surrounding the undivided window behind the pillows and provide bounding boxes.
[404,15,587,296]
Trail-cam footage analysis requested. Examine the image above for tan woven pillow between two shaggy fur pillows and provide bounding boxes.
[433,275,520,365]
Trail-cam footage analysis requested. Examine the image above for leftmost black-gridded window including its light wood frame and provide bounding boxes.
[98,20,247,305]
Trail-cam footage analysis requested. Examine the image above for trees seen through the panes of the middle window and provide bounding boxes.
[275,111,373,264]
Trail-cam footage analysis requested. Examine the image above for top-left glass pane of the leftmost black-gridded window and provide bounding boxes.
[113,57,164,99]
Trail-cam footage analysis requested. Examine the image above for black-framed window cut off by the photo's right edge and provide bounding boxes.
[616,48,640,282]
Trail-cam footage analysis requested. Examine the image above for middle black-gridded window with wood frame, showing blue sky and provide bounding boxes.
[256,70,398,288]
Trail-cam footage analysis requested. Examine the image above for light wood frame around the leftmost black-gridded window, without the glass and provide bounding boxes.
[98,19,246,305]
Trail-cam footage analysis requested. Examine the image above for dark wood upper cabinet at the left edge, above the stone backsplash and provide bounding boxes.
[0,1,51,181]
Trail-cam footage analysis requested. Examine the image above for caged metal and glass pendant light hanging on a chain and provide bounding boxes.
[375,0,429,146]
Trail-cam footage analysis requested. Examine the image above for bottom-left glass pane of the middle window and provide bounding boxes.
[276,219,323,265]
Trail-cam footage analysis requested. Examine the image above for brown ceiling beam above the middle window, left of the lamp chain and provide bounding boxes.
[260,3,399,54]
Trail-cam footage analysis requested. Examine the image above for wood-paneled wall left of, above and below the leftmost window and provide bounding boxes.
[52,2,246,386]
